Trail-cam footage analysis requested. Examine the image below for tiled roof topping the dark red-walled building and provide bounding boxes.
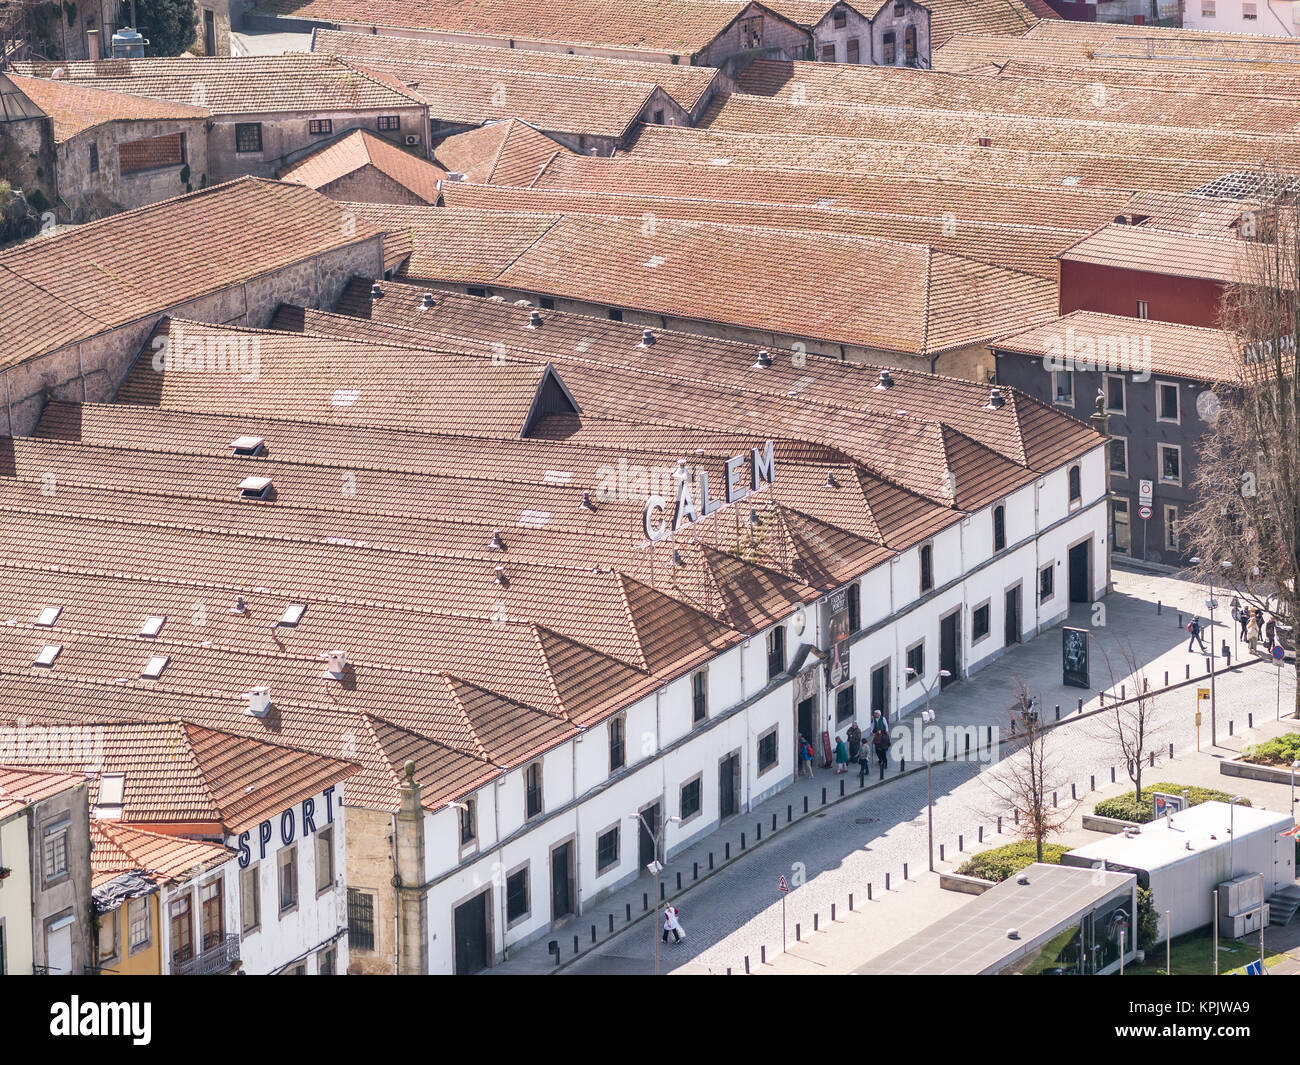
[1058,225,1253,282]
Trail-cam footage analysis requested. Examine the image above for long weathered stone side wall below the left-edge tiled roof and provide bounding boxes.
[0,232,384,436]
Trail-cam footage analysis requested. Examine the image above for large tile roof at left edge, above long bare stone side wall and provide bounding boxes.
[0,178,378,367]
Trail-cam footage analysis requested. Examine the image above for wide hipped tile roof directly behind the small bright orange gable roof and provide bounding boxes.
[14,52,423,114]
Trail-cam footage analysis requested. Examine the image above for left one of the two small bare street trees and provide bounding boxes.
[979,677,1078,862]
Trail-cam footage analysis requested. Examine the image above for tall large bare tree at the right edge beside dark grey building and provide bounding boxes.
[1182,173,1300,718]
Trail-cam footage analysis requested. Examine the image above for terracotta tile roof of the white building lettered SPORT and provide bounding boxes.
[0,723,356,834]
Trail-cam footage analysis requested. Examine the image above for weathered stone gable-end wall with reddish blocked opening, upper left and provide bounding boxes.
[59,118,211,221]
